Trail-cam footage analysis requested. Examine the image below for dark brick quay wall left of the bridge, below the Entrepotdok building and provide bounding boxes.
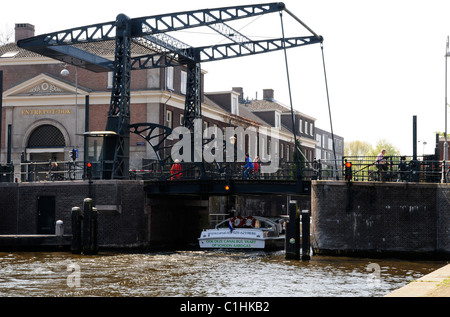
[0,181,148,247]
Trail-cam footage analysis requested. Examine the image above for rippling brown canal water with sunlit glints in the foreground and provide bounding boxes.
[0,251,446,298]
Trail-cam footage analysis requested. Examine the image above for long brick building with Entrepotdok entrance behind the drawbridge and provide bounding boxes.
[0,24,342,178]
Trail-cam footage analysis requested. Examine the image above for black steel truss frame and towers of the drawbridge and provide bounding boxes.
[18,3,323,179]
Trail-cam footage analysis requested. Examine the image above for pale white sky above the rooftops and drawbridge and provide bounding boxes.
[0,0,450,155]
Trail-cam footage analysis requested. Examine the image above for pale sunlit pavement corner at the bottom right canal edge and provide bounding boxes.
[385,264,450,297]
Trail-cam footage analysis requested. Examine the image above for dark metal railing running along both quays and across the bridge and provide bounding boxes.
[0,156,450,183]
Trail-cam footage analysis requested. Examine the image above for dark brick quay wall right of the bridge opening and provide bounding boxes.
[311,181,450,258]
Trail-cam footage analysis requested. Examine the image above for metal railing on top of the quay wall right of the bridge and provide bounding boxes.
[341,155,442,183]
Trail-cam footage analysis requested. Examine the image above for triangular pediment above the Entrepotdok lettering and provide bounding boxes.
[3,74,88,97]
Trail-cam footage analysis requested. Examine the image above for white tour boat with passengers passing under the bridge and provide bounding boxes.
[198,216,285,250]
